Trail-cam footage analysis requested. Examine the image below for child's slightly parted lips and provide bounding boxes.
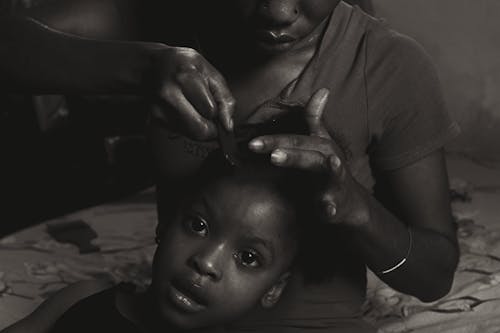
[168,282,206,313]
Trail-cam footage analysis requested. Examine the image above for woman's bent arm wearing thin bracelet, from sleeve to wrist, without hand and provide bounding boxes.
[353,150,459,301]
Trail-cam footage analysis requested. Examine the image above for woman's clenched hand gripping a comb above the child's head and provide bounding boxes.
[152,46,235,141]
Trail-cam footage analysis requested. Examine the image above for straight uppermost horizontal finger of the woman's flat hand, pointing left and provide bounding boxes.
[248,134,334,155]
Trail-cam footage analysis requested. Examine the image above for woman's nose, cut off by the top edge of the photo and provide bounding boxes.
[260,0,299,26]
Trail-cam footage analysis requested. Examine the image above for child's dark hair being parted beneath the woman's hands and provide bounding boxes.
[176,150,344,283]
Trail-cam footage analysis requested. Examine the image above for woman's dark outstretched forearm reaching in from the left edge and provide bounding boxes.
[0,16,162,94]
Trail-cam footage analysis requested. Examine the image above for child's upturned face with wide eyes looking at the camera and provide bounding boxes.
[152,179,297,329]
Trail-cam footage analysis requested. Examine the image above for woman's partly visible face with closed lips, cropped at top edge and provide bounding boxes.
[220,0,339,53]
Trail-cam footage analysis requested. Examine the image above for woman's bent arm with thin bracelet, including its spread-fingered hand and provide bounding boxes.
[250,90,458,301]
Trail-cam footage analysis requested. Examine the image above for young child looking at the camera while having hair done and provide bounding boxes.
[3,153,324,333]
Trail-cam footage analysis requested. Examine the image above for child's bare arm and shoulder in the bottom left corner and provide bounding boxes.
[0,280,112,333]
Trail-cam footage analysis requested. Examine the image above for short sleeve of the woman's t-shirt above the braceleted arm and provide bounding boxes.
[365,29,459,170]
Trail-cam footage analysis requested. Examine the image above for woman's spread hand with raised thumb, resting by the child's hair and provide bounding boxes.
[249,89,369,226]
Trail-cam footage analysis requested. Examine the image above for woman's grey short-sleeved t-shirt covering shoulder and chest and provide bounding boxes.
[266,2,458,189]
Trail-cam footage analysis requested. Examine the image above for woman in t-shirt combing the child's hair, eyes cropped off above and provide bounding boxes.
[0,0,458,332]
